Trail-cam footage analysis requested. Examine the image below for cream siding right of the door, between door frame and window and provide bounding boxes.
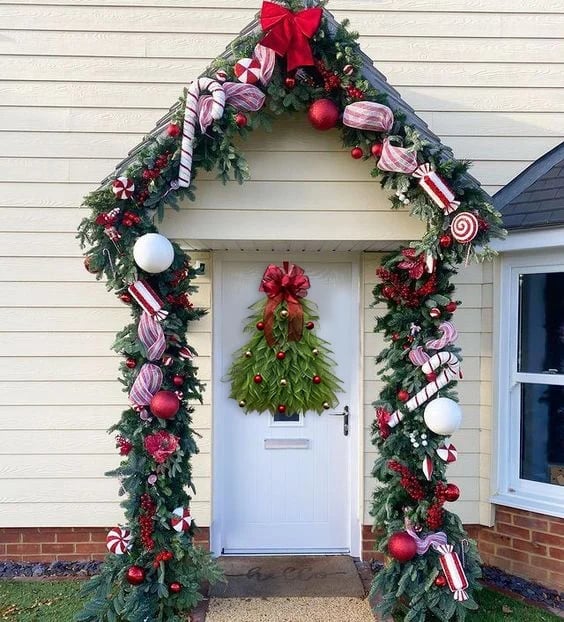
[363,253,492,525]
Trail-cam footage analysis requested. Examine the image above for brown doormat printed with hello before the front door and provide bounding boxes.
[211,555,364,598]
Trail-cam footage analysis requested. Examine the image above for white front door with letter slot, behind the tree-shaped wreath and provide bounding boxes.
[212,254,360,554]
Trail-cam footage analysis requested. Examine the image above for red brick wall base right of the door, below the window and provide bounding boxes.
[362,506,564,591]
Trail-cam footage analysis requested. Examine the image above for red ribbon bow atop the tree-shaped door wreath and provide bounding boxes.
[259,261,310,347]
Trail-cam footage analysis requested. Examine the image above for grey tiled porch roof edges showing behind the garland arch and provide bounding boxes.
[102,8,458,185]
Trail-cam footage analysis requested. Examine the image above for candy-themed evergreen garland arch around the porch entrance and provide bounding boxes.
[77,0,503,622]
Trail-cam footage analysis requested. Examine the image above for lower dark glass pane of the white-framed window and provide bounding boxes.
[520,384,564,486]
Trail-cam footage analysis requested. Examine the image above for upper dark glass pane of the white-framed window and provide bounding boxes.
[518,272,564,374]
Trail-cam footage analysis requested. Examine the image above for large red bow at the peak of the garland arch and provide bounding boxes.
[260,0,323,71]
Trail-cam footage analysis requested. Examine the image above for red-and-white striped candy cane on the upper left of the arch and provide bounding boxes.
[178,77,225,188]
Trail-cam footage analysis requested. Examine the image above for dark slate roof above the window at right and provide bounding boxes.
[493,142,564,230]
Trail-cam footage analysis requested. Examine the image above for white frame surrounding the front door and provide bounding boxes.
[210,251,364,557]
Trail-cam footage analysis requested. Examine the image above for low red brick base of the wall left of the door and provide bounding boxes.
[0,527,209,562]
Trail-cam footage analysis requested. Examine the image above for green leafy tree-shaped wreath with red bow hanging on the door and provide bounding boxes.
[229,261,341,416]
